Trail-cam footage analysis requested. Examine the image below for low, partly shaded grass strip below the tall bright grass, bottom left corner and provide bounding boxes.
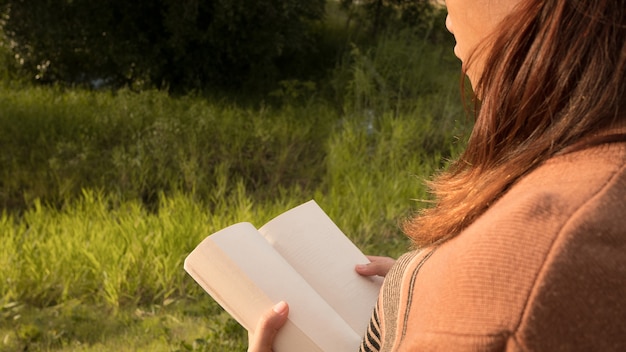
[0,296,247,352]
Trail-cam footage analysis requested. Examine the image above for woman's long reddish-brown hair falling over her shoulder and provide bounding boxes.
[404,0,626,247]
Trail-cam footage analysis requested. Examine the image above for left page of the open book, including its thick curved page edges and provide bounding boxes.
[185,223,361,352]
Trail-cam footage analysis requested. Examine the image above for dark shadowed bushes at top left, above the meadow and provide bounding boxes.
[0,0,325,88]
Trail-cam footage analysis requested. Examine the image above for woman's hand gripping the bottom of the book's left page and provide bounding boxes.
[248,301,289,352]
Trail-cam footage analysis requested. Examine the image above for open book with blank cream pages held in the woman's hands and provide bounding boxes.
[185,201,382,352]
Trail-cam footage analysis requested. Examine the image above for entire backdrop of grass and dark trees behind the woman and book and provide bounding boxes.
[0,0,467,351]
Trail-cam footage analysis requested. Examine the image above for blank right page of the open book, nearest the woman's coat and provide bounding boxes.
[259,201,382,336]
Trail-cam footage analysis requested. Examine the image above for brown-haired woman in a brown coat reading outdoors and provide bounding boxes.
[250,0,626,352]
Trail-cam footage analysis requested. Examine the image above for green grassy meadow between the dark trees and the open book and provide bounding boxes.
[0,26,468,351]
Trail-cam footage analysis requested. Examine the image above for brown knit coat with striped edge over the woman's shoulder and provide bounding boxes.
[362,138,626,351]
